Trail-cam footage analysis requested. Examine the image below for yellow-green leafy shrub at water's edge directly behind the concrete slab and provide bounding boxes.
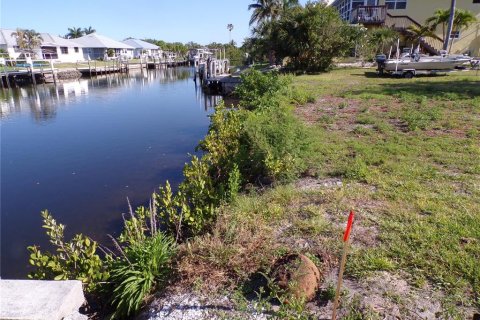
[27,210,109,291]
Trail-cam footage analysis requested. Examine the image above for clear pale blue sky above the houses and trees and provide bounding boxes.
[0,0,318,45]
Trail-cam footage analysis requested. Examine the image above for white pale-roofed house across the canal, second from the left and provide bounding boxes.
[75,33,135,60]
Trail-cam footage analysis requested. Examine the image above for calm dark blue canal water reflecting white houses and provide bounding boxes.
[0,68,219,278]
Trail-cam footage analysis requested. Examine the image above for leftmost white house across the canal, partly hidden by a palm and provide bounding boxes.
[0,29,83,62]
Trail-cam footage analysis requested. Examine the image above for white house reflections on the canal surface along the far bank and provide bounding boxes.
[0,68,220,121]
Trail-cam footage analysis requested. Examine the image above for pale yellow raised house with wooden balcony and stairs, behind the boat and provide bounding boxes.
[332,0,480,56]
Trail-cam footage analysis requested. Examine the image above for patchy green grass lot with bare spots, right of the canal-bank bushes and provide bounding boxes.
[180,69,480,319]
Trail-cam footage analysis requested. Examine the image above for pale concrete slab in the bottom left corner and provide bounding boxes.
[0,280,85,320]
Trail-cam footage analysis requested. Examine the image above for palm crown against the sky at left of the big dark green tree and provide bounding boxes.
[248,0,298,25]
